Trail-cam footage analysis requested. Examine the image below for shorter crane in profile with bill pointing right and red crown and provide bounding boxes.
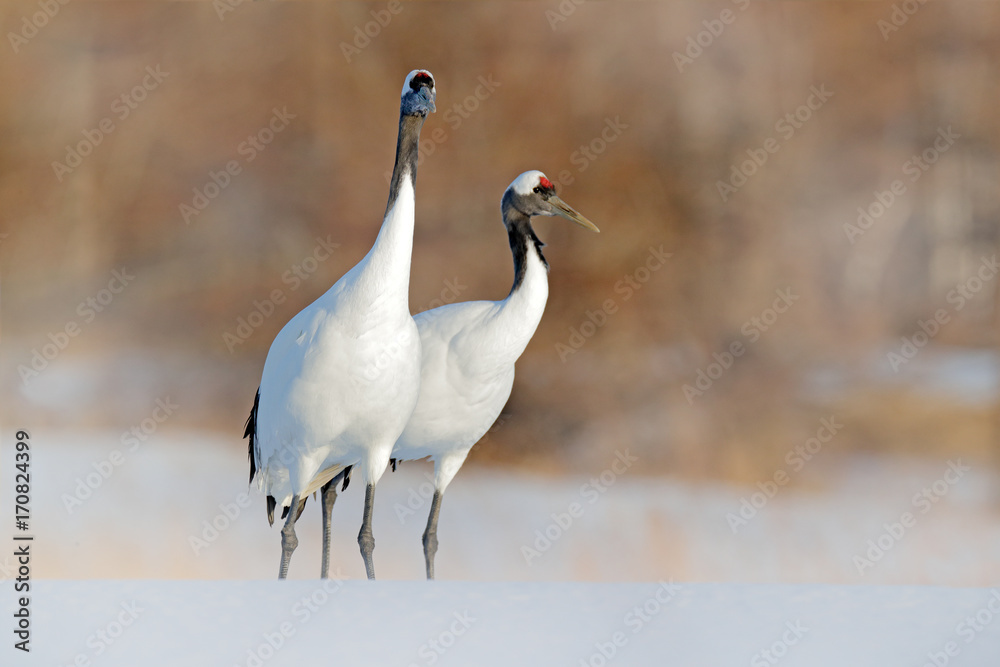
[392,171,600,579]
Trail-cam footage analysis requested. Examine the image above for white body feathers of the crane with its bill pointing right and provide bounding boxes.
[392,222,549,493]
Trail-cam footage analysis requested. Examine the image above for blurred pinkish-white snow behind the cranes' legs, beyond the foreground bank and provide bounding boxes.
[0,429,1000,586]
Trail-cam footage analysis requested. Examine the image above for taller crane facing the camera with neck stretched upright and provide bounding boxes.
[244,70,436,579]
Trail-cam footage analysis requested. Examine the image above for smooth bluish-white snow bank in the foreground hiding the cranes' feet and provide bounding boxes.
[0,580,1000,667]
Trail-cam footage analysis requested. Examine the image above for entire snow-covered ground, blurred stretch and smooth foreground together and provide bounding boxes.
[0,427,1000,667]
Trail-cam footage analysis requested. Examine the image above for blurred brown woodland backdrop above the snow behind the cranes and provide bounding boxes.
[0,1,1000,481]
